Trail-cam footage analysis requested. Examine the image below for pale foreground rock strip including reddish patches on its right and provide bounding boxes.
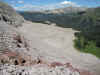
[0,62,92,75]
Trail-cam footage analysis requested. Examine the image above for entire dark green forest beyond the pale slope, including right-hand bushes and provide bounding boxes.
[21,7,100,57]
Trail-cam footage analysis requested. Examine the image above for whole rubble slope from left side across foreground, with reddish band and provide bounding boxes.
[0,21,91,75]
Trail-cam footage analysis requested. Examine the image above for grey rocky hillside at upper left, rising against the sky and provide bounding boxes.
[0,2,24,26]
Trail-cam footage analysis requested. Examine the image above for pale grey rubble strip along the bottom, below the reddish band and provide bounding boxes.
[0,64,80,75]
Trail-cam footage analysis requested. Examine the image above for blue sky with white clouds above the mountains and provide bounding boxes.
[1,0,100,11]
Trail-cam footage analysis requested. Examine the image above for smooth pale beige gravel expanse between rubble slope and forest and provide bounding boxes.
[19,22,100,75]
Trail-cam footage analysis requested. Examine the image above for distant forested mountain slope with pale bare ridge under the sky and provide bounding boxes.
[20,7,87,27]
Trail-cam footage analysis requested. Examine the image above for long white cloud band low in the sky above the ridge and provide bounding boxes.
[15,0,79,11]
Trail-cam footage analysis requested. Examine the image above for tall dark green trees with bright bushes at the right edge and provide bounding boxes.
[74,8,100,57]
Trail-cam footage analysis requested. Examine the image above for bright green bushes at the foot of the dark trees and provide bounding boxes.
[74,38,100,58]
